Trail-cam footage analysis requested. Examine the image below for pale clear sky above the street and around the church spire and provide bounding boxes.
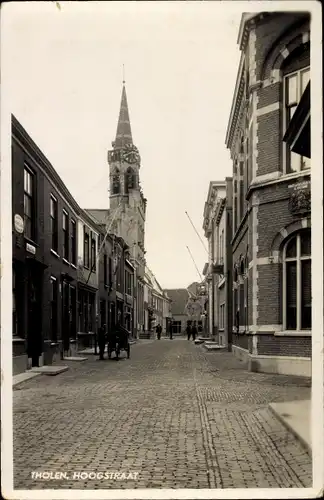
[1,2,247,288]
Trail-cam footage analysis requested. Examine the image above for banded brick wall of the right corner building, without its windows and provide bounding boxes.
[227,13,311,376]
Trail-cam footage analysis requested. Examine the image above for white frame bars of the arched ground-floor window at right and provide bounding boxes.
[282,231,312,334]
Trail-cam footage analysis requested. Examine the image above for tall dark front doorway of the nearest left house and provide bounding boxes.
[26,262,43,366]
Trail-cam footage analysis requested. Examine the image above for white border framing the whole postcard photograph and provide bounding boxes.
[0,1,324,499]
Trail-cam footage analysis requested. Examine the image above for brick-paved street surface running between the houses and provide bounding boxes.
[13,339,312,489]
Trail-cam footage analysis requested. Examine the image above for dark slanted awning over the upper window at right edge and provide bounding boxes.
[283,82,311,158]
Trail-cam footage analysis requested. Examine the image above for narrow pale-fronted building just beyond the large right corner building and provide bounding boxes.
[203,177,232,350]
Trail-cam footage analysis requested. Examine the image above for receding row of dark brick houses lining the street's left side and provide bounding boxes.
[12,116,134,374]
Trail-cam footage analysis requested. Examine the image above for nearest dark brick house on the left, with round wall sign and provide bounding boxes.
[12,116,81,374]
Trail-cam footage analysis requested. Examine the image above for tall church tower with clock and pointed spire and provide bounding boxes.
[108,82,147,336]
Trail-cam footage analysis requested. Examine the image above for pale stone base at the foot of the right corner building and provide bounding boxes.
[232,345,312,377]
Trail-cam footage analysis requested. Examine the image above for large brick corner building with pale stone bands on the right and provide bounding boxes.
[226,12,311,375]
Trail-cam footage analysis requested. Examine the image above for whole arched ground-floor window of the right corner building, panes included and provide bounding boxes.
[283,229,312,331]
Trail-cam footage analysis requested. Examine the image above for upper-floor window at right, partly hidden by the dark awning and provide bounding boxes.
[284,67,311,173]
